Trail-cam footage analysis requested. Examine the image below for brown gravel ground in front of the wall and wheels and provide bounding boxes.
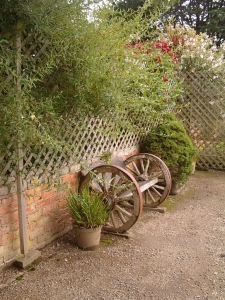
[0,171,225,300]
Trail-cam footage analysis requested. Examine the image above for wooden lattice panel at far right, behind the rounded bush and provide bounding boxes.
[182,71,225,170]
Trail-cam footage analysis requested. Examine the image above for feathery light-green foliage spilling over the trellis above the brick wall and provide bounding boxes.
[0,0,180,155]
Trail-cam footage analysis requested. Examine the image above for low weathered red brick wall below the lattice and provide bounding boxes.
[0,173,80,267]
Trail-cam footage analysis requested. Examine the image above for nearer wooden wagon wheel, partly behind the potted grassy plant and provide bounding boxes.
[80,165,143,233]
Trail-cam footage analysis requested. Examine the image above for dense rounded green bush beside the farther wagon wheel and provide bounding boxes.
[140,114,198,194]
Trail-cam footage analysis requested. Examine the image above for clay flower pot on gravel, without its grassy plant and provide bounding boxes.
[74,226,102,250]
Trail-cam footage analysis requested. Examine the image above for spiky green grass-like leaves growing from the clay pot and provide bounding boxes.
[66,188,109,228]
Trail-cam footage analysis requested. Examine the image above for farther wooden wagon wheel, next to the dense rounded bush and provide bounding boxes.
[124,153,172,208]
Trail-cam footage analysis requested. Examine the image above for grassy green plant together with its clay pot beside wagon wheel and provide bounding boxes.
[66,187,109,250]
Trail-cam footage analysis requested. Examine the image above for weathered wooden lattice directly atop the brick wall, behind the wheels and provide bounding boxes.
[0,113,157,191]
